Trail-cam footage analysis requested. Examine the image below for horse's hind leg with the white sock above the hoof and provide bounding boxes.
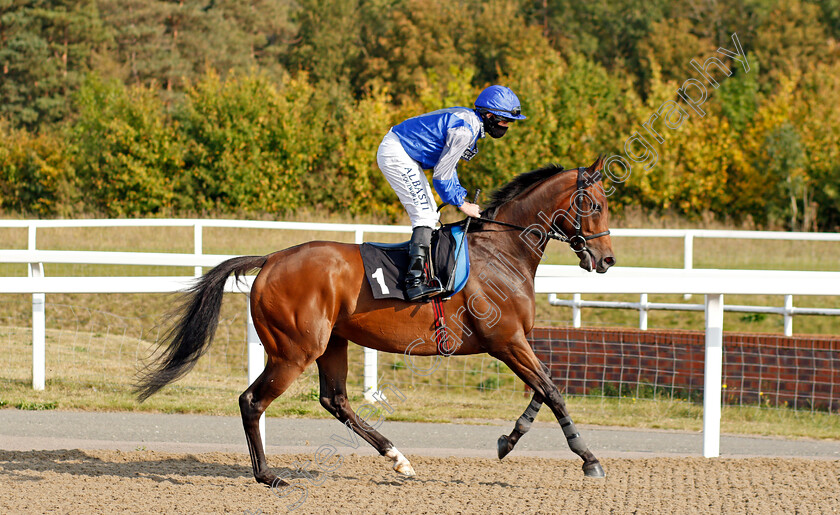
[316,336,415,476]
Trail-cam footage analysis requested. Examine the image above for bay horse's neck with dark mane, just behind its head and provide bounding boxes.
[482,174,569,278]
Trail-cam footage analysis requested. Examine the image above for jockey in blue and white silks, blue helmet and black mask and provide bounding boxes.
[376,86,525,301]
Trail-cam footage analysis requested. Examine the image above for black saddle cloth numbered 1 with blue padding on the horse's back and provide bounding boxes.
[359,223,470,301]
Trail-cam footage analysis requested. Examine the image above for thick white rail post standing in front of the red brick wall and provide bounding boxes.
[703,294,723,458]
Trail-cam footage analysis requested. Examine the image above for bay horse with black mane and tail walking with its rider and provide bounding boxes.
[135,156,615,486]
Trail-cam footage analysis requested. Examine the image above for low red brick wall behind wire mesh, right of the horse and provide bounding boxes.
[529,327,840,411]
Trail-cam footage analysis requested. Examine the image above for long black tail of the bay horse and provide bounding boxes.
[134,256,267,402]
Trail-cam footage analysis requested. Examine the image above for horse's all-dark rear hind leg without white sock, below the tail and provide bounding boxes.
[239,358,311,486]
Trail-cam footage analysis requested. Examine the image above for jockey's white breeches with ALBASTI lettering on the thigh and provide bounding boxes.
[376,131,440,229]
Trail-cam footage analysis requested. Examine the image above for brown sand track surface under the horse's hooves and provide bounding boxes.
[0,450,840,514]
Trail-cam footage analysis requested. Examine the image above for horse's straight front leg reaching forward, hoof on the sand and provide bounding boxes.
[491,338,605,477]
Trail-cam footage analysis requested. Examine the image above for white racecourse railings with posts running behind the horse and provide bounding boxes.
[0,220,840,457]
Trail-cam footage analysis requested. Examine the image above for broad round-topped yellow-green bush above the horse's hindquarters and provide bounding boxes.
[176,73,327,213]
